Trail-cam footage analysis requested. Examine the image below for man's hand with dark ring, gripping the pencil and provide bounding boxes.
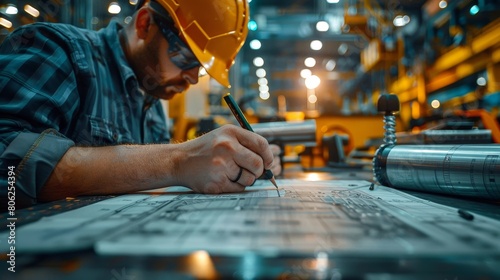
[176,125,281,193]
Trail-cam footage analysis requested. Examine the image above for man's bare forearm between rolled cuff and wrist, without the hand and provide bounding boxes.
[38,145,177,201]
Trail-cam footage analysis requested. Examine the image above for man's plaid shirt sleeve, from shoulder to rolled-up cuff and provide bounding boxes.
[0,24,79,205]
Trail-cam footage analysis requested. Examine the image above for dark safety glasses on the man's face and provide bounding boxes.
[153,13,201,70]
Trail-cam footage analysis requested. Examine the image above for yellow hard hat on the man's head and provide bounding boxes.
[155,0,250,87]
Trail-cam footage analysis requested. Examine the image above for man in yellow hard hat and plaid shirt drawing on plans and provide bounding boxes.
[0,0,280,205]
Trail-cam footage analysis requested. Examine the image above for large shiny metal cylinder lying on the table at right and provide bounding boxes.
[373,144,500,199]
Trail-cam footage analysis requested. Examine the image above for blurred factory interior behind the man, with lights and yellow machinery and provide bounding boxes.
[0,0,500,163]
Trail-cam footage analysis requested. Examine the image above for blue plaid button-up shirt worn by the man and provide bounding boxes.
[0,22,169,205]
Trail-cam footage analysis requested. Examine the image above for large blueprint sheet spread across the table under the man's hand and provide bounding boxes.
[2,180,500,257]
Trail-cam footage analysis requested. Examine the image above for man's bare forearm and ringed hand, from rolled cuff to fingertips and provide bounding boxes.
[38,125,279,200]
